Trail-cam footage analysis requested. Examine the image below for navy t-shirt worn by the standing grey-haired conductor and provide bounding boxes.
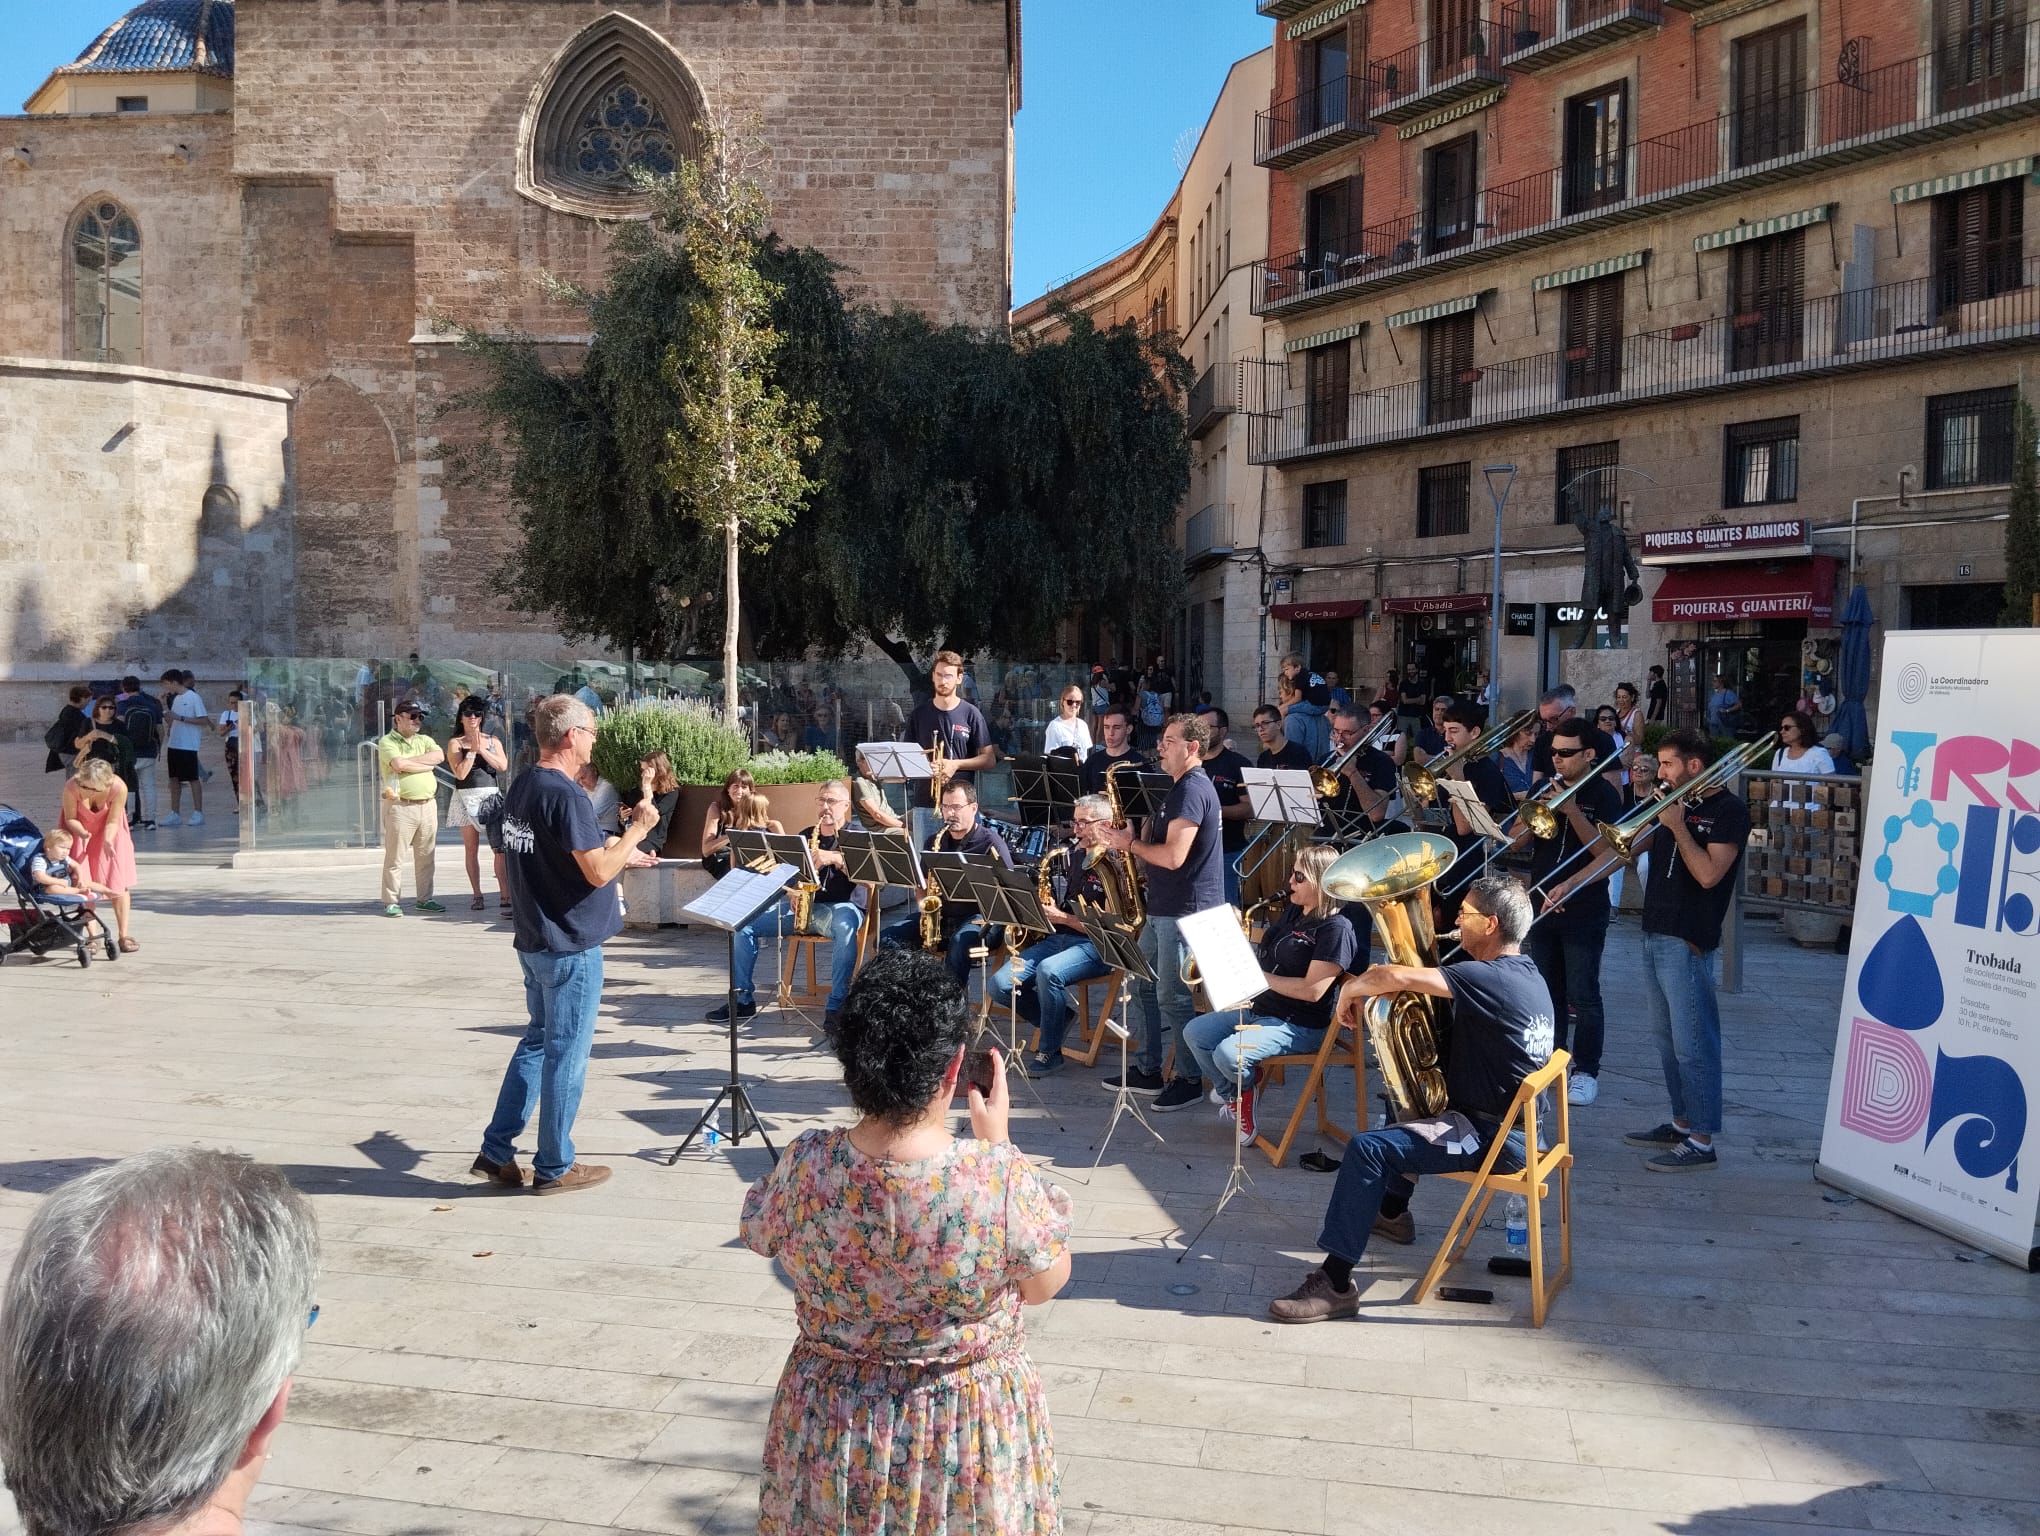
[502,767,624,955]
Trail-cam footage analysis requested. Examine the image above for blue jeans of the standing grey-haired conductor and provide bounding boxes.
[481,946,602,1179]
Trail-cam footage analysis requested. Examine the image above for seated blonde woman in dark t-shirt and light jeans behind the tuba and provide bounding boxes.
[1183,842,1363,1144]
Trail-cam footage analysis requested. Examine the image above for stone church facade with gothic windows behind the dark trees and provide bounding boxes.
[0,0,1020,718]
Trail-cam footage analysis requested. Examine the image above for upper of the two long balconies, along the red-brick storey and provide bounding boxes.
[1253,20,2040,316]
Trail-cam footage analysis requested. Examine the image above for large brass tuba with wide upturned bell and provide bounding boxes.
[1324,832,1459,1124]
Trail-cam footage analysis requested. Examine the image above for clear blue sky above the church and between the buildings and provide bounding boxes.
[0,0,1273,304]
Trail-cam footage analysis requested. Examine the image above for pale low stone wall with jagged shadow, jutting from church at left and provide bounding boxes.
[0,359,296,730]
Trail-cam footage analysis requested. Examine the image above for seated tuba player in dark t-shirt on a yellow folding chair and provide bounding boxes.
[1269,875,1552,1322]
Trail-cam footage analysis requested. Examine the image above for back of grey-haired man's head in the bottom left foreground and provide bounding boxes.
[0,1148,318,1536]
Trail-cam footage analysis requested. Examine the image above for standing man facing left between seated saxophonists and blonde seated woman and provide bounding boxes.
[1102,714,1226,1110]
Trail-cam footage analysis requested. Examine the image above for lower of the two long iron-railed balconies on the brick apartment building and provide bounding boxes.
[1248,259,2040,463]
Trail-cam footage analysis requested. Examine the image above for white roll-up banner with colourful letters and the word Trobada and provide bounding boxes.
[1816,630,2040,1269]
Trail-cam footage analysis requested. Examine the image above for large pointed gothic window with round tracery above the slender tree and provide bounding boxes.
[516,14,702,218]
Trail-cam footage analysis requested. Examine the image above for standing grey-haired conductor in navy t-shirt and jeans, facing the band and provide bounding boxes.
[471,694,659,1195]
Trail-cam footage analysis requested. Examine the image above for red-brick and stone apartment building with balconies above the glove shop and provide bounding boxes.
[1246,0,2040,724]
